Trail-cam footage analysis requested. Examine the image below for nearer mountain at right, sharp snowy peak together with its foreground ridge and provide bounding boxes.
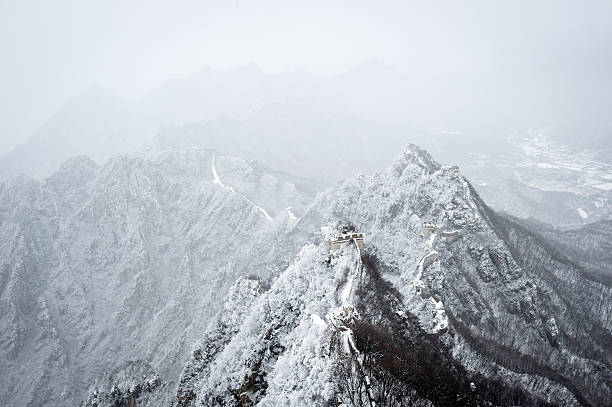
[177,146,612,406]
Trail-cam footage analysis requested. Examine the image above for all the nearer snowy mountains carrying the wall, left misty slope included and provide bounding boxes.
[0,145,612,407]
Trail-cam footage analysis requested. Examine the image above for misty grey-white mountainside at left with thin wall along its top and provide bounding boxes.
[0,149,312,406]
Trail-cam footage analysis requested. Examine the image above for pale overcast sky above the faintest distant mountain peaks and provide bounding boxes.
[0,0,612,152]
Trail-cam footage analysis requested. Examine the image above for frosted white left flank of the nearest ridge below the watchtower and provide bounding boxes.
[177,245,347,406]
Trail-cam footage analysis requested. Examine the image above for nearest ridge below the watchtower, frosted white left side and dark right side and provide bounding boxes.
[176,246,584,406]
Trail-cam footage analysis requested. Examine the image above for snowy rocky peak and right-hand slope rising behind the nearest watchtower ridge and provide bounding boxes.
[305,147,612,405]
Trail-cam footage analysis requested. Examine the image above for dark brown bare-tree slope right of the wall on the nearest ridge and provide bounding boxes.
[335,253,556,407]
